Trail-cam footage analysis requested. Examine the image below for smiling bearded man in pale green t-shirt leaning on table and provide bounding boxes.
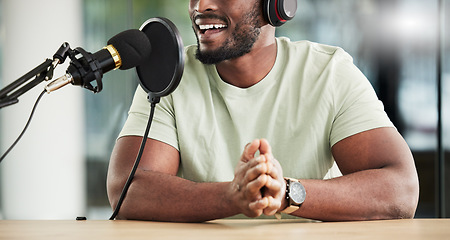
[108,0,419,222]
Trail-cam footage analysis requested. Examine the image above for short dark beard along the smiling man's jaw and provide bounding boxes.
[195,4,262,65]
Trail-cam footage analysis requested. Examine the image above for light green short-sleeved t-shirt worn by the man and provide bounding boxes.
[120,38,393,182]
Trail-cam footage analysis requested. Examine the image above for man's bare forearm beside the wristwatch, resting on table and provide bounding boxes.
[293,168,418,221]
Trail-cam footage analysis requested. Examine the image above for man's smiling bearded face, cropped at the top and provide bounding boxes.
[189,0,262,64]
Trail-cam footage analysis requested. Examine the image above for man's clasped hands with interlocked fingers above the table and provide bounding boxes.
[230,139,286,217]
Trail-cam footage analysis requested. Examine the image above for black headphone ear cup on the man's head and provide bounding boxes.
[263,0,297,27]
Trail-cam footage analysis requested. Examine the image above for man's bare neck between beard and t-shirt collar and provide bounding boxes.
[216,26,277,88]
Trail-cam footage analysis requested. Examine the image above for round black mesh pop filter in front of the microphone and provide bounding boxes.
[136,18,184,100]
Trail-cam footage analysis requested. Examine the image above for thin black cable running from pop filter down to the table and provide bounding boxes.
[109,103,156,220]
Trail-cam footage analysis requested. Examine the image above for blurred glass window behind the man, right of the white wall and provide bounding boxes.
[78,0,450,217]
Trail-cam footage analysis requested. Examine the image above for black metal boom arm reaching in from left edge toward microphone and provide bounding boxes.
[0,43,70,109]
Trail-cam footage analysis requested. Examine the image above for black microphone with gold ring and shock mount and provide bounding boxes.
[45,29,151,93]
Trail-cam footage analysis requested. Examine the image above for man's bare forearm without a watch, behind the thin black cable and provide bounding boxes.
[108,170,239,222]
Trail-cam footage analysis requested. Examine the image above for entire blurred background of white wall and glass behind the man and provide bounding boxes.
[0,0,450,219]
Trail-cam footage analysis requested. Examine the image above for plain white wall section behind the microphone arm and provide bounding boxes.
[0,0,85,219]
